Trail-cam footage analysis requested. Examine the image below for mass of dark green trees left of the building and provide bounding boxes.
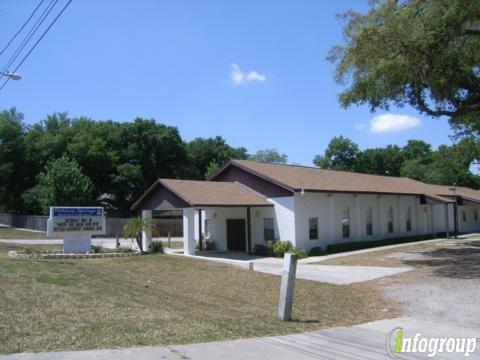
[0,109,248,216]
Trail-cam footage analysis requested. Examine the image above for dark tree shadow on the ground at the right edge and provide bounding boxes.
[403,241,480,279]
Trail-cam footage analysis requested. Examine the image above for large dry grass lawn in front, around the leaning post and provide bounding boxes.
[0,245,396,353]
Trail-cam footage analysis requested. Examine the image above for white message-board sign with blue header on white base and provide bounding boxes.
[47,206,105,254]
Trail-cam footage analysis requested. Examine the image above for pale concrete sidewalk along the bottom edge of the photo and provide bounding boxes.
[0,318,480,360]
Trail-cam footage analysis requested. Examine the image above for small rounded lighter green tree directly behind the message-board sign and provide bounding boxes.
[24,155,93,214]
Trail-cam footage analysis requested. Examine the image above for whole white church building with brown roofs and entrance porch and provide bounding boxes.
[132,160,480,255]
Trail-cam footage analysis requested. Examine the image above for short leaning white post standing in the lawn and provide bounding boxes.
[278,253,297,321]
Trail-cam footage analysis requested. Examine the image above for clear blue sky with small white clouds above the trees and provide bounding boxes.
[0,0,451,165]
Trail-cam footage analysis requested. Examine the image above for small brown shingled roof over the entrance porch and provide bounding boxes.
[158,179,272,206]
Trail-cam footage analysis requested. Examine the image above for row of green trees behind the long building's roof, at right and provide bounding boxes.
[313,136,480,189]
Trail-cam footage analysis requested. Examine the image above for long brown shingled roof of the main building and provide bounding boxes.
[231,160,480,202]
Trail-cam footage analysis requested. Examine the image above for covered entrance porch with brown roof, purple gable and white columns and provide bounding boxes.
[132,179,273,255]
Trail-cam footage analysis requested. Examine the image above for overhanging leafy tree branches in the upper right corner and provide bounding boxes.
[328,0,480,138]
